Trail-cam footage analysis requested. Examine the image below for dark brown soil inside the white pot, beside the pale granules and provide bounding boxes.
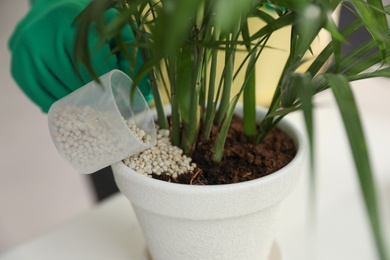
[153,116,296,185]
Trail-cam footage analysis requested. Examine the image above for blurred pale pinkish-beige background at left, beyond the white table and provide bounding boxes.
[0,0,94,254]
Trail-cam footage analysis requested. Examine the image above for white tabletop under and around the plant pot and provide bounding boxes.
[0,78,390,260]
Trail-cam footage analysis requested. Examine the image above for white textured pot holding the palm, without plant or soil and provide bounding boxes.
[112,106,307,260]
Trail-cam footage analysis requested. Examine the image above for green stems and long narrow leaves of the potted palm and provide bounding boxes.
[75,0,390,259]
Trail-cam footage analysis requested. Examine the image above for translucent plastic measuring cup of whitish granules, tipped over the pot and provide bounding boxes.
[48,70,156,173]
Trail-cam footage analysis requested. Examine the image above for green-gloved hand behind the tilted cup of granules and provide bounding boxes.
[9,0,152,112]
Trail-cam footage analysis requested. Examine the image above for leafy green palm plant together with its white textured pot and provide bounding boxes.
[75,0,390,259]
